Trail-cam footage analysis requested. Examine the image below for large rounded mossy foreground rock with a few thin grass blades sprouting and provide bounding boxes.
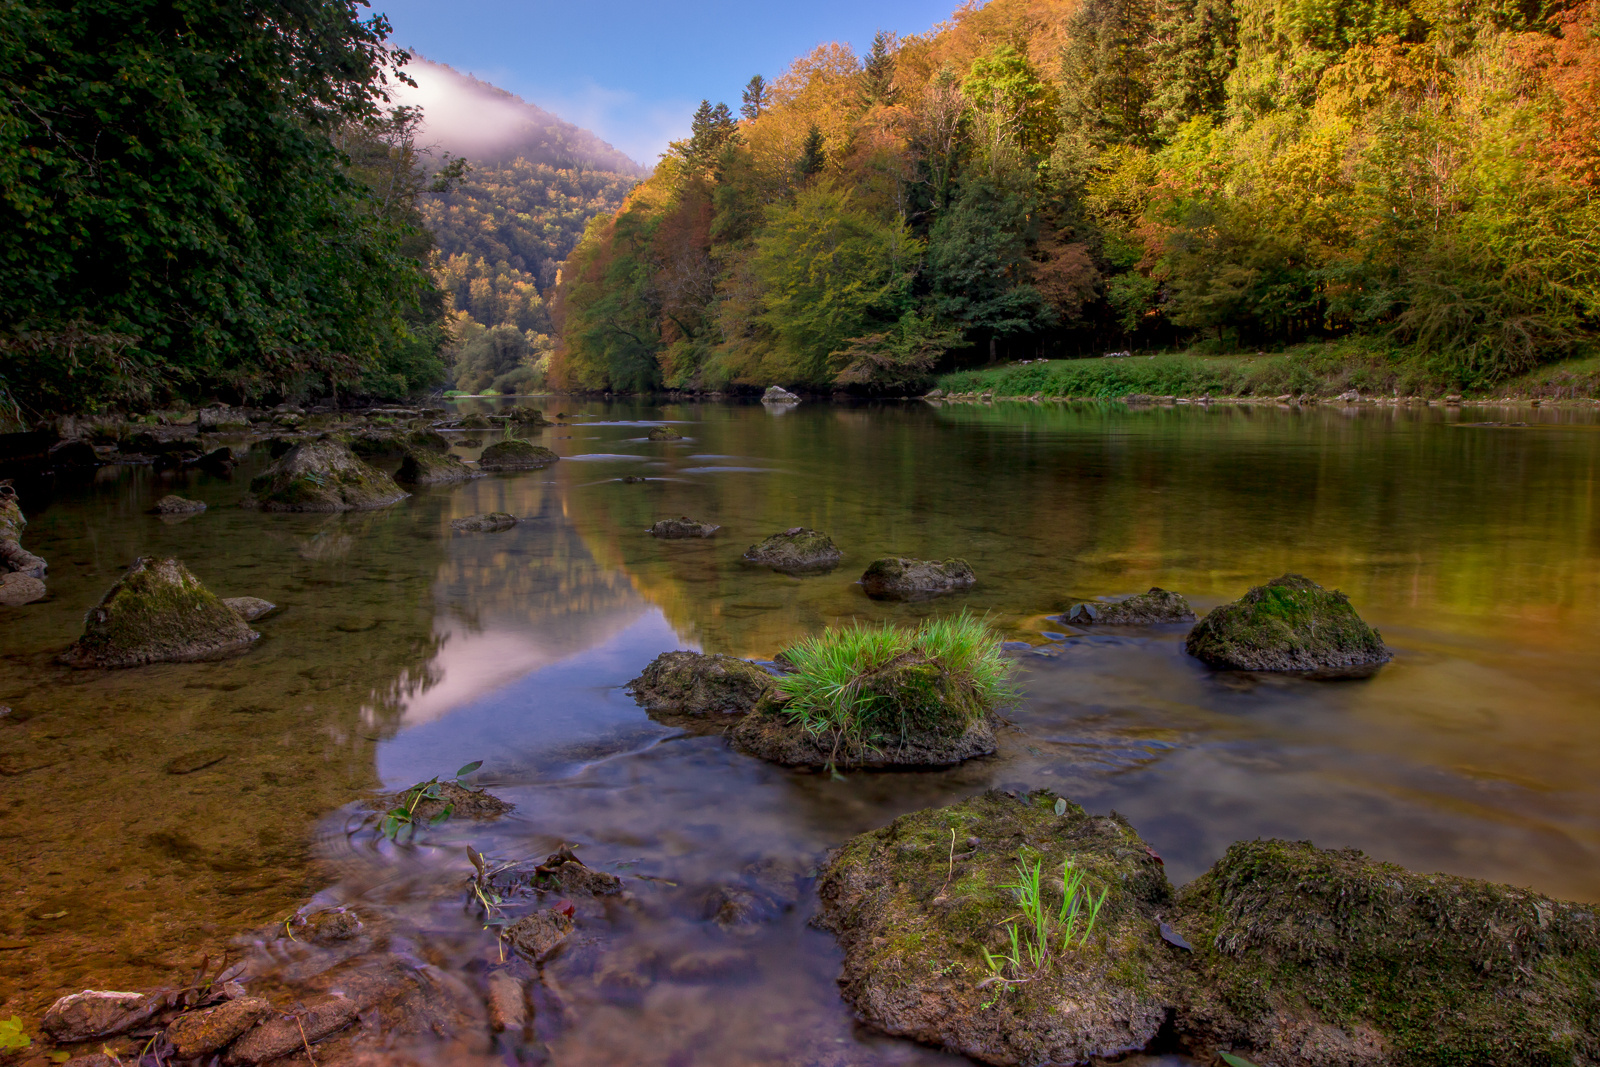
[818,792,1176,1064]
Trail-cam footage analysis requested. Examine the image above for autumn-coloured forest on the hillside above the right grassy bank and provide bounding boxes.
[554,0,1600,390]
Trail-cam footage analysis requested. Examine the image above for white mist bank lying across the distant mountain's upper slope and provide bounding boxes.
[390,54,650,178]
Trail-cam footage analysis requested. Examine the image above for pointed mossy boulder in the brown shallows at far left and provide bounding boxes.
[61,557,261,667]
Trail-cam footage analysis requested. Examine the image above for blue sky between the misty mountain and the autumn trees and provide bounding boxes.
[373,0,958,165]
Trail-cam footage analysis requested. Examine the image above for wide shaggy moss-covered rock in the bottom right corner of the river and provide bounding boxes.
[1176,841,1600,1067]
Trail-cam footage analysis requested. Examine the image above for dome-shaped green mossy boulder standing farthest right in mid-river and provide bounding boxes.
[1184,574,1390,672]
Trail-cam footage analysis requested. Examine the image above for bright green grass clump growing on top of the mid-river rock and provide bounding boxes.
[778,611,1013,744]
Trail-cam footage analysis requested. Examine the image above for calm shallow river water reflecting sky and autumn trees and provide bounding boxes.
[0,398,1600,1065]
